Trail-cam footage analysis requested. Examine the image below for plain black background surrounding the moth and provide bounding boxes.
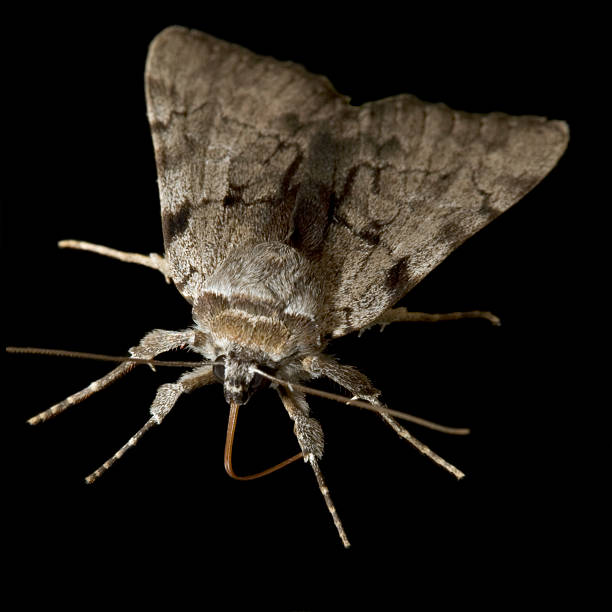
[2,4,603,610]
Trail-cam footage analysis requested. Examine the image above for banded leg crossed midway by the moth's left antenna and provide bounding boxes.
[28,329,193,425]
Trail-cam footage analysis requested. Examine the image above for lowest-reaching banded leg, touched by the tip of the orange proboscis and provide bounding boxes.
[278,387,351,548]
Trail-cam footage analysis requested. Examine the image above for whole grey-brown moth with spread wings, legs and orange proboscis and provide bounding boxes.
[17,27,569,546]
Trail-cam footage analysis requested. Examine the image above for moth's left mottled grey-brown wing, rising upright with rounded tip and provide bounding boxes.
[145,26,344,303]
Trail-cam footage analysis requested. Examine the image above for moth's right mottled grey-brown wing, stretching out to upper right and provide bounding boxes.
[321,95,569,337]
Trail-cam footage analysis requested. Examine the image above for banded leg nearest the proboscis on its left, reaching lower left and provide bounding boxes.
[85,365,216,484]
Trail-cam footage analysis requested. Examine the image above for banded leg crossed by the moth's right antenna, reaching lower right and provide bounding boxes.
[302,355,465,478]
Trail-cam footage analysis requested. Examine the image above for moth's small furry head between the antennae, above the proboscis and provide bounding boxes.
[213,353,270,405]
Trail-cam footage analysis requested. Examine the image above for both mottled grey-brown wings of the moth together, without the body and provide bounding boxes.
[146,27,568,337]
